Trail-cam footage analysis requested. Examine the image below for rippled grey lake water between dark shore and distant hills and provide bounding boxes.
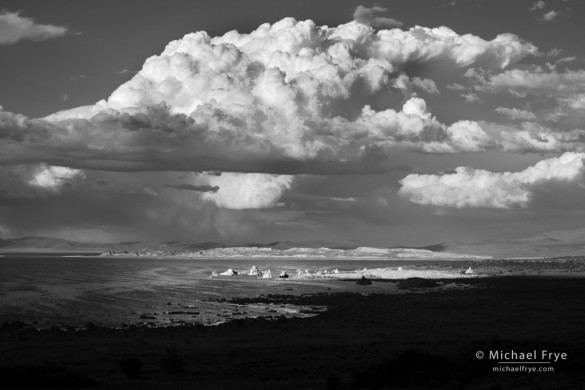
[0,254,492,328]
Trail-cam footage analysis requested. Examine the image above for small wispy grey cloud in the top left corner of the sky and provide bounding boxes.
[0,11,69,45]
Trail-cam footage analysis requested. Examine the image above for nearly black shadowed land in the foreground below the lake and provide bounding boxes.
[0,277,585,390]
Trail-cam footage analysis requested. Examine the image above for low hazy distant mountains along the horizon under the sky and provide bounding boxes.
[0,228,585,257]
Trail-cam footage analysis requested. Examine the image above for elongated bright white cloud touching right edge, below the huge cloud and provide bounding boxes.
[399,153,585,208]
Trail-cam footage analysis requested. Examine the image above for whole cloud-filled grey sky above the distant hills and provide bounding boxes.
[0,0,585,246]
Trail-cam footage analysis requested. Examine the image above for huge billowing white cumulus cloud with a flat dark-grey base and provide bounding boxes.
[0,18,536,174]
